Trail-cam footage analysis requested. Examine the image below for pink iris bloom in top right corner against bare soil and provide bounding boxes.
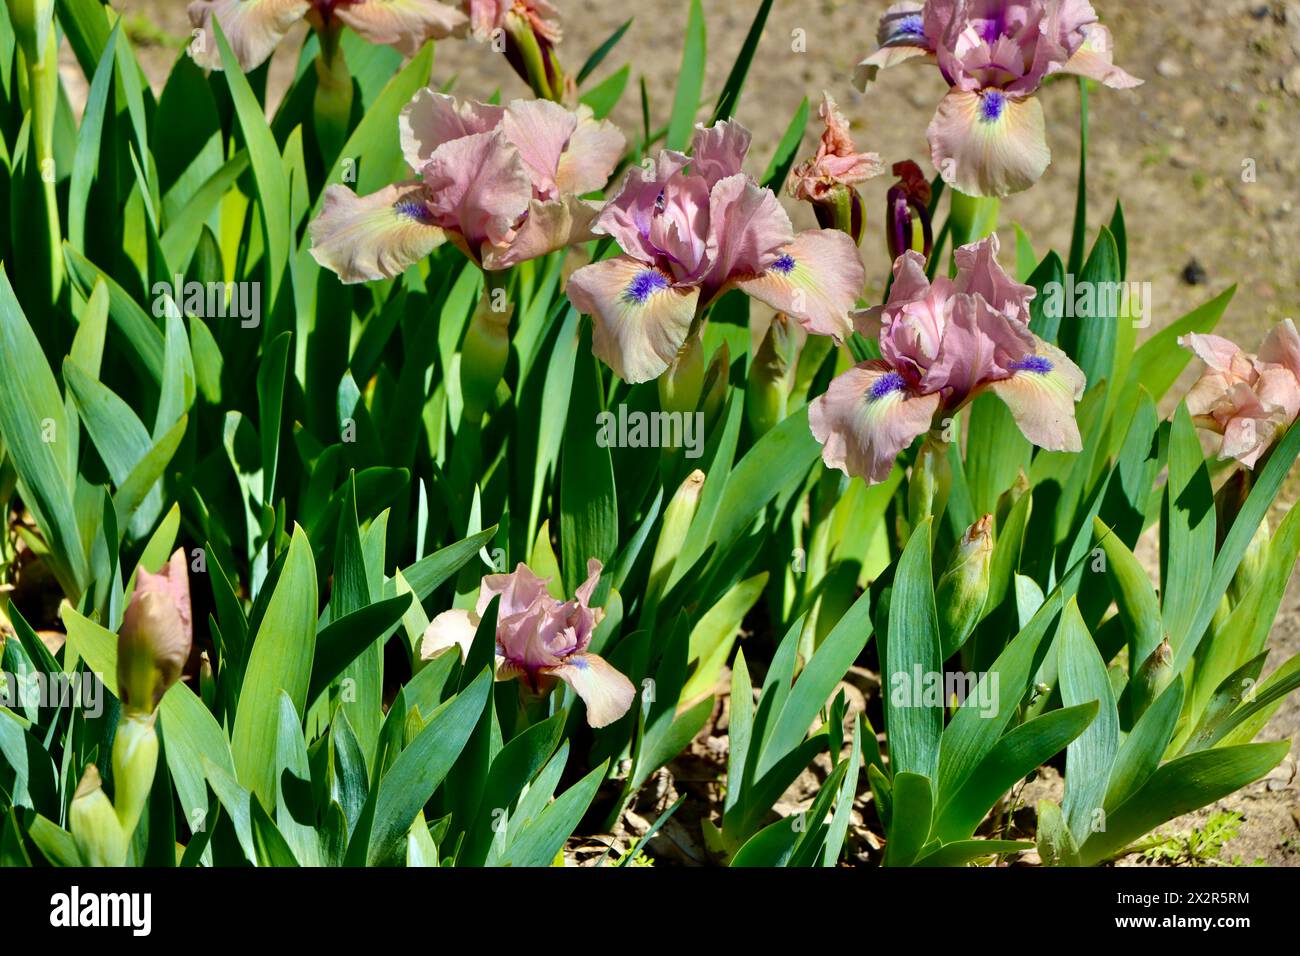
[854,0,1141,196]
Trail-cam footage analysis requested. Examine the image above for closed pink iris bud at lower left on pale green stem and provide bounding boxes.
[117,549,194,714]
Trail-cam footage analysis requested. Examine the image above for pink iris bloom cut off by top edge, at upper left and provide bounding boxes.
[189,0,469,70]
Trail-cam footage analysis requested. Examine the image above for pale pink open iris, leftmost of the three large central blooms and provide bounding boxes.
[311,88,624,282]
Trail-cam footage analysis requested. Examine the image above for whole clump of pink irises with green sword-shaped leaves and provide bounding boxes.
[0,0,1300,866]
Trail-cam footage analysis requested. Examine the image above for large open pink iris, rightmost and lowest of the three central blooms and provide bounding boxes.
[809,235,1084,484]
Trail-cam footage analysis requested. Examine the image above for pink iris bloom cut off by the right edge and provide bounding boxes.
[1178,319,1300,468]
